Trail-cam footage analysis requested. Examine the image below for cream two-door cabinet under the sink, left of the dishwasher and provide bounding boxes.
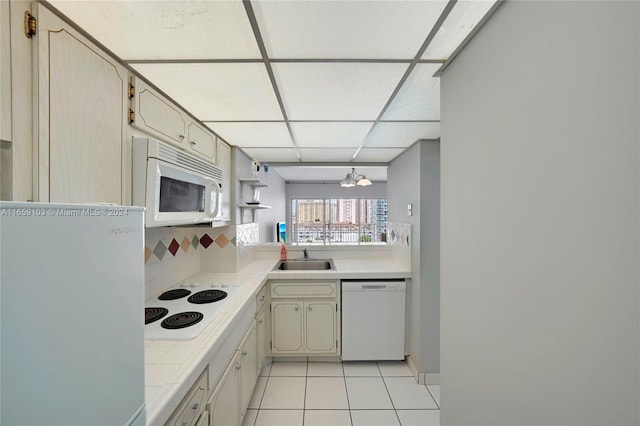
[271,282,340,355]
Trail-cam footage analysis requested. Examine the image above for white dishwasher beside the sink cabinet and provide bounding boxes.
[342,280,406,361]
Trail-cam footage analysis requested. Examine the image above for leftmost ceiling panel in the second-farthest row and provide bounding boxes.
[205,122,293,148]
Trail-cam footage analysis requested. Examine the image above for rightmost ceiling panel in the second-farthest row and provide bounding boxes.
[358,122,440,149]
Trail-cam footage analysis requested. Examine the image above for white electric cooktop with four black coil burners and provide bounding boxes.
[144,279,240,340]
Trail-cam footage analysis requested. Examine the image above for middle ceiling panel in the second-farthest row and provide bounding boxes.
[291,122,373,148]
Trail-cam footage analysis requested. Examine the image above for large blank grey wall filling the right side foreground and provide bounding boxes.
[441,1,640,425]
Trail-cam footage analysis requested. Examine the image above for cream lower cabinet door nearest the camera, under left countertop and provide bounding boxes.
[208,352,240,426]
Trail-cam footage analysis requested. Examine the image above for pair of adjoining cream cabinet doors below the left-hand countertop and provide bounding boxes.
[207,321,258,426]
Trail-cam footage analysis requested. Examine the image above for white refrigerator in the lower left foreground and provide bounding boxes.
[0,202,146,426]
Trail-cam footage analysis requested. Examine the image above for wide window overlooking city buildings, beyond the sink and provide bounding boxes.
[291,198,387,245]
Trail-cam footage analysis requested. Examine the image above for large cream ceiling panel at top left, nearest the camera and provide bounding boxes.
[51,0,261,60]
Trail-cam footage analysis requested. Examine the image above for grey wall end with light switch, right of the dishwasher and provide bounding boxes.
[387,141,440,381]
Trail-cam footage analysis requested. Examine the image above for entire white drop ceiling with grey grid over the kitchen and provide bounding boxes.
[46,0,497,175]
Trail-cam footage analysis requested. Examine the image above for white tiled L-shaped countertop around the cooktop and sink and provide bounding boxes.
[144,255,411,426]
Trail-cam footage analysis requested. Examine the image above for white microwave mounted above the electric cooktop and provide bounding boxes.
[132,138,223,227]
